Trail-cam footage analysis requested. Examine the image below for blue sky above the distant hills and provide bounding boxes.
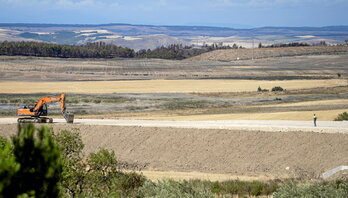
[0,0,348,27]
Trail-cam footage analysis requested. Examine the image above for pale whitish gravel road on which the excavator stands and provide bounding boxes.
[0,118,348,134]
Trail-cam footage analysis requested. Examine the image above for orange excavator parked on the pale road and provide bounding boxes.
[17,93,74,123]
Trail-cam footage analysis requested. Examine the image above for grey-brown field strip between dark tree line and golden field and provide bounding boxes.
[0,53,348,82]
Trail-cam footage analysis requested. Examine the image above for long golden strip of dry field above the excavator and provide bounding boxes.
[0,79,347,93]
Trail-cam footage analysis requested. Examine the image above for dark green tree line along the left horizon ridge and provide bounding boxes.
[0,41,238,60]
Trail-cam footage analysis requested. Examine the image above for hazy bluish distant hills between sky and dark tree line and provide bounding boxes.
[0,23,348,50]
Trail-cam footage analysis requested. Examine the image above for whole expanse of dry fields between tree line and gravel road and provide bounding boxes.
[0,51,348,120]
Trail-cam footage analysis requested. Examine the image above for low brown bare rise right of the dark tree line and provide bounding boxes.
[189,46,348,61]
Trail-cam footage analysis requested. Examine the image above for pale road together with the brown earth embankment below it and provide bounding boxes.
[0,118,348,180]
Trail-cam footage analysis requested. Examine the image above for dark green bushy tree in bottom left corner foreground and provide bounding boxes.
[1,124,62,197]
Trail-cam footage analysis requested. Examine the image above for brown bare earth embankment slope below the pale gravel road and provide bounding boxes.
[0,119,348,178]
